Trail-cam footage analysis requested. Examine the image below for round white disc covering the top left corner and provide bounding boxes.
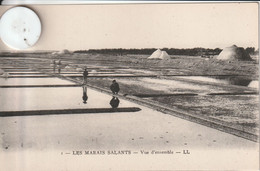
[0,7,41,49]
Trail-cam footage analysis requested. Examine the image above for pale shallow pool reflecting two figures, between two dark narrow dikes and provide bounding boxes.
[0,87,134,111]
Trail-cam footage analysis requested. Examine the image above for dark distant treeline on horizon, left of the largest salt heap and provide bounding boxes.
[74,48,221,56]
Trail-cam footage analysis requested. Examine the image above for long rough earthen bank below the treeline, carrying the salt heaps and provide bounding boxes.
[66,54,259,79]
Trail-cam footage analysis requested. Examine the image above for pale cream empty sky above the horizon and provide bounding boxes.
[0,3,258,51]
